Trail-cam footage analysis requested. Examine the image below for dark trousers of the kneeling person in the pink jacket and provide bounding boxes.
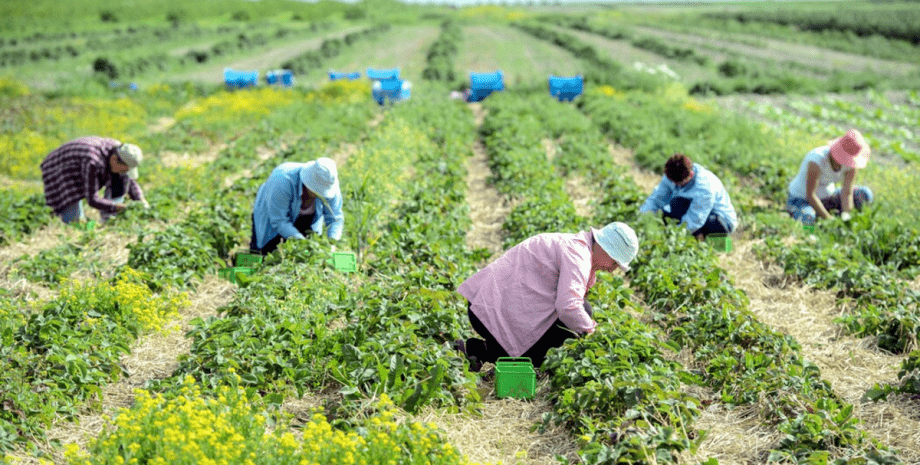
[466,301,594,368]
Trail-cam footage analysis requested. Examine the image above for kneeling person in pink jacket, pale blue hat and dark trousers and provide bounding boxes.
[454,222,639,371]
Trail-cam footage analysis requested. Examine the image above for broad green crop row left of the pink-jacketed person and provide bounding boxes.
[146,90,478,421]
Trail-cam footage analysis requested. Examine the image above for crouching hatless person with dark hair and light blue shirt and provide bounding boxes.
[639,153,738,240]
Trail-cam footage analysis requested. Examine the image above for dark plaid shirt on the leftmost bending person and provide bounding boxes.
[41,136,144,215]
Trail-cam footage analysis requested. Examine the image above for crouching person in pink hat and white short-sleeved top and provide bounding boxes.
[786,129,872,225]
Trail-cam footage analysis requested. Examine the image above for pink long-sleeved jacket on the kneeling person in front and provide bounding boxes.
[457,230,597,357]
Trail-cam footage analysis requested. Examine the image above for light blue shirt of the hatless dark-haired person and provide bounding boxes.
[639,163,738,232]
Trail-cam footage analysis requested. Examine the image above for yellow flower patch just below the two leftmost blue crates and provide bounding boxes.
[176,87,295,124]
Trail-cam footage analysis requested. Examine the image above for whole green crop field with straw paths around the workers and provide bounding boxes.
[0,0,920,465]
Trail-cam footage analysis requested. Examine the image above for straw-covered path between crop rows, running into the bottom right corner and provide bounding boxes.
[720,240,920,463]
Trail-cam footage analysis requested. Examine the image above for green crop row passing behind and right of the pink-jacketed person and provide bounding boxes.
[481,92,702,464]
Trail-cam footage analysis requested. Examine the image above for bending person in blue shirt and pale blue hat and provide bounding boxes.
[249,158,345,255]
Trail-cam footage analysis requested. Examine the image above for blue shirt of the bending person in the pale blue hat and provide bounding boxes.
[252,162,345,248]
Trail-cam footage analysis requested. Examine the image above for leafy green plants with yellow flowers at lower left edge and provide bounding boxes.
[0,267,188,450]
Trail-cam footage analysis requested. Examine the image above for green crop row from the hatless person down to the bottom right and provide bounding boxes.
[564,86,898,463]
